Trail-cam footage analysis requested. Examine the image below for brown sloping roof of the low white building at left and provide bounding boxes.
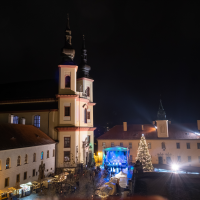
[0,124,55,150]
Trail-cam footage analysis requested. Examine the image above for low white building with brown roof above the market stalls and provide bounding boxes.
[0,124,55,191]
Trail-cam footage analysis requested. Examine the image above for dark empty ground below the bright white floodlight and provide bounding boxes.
[135,172,200,200]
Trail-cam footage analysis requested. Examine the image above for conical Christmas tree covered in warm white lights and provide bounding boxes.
[136,134,153,171]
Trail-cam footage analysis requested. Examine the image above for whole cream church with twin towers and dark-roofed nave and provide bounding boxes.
[0,14,95,168]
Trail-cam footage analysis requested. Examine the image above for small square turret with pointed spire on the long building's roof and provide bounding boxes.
[156,99,169,137]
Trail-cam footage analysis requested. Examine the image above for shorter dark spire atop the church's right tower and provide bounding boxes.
[78,35,91,78]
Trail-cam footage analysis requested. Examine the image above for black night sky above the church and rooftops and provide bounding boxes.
[0,0,200,126]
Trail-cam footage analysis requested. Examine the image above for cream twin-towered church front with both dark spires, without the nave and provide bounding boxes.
[56,16,95,167]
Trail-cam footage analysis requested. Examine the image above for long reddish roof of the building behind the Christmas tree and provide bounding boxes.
[98,124,200,140]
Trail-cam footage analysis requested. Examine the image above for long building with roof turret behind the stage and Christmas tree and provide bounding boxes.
[97,101,200,167]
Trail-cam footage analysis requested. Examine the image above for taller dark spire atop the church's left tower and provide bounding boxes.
[62,14,75,62]
